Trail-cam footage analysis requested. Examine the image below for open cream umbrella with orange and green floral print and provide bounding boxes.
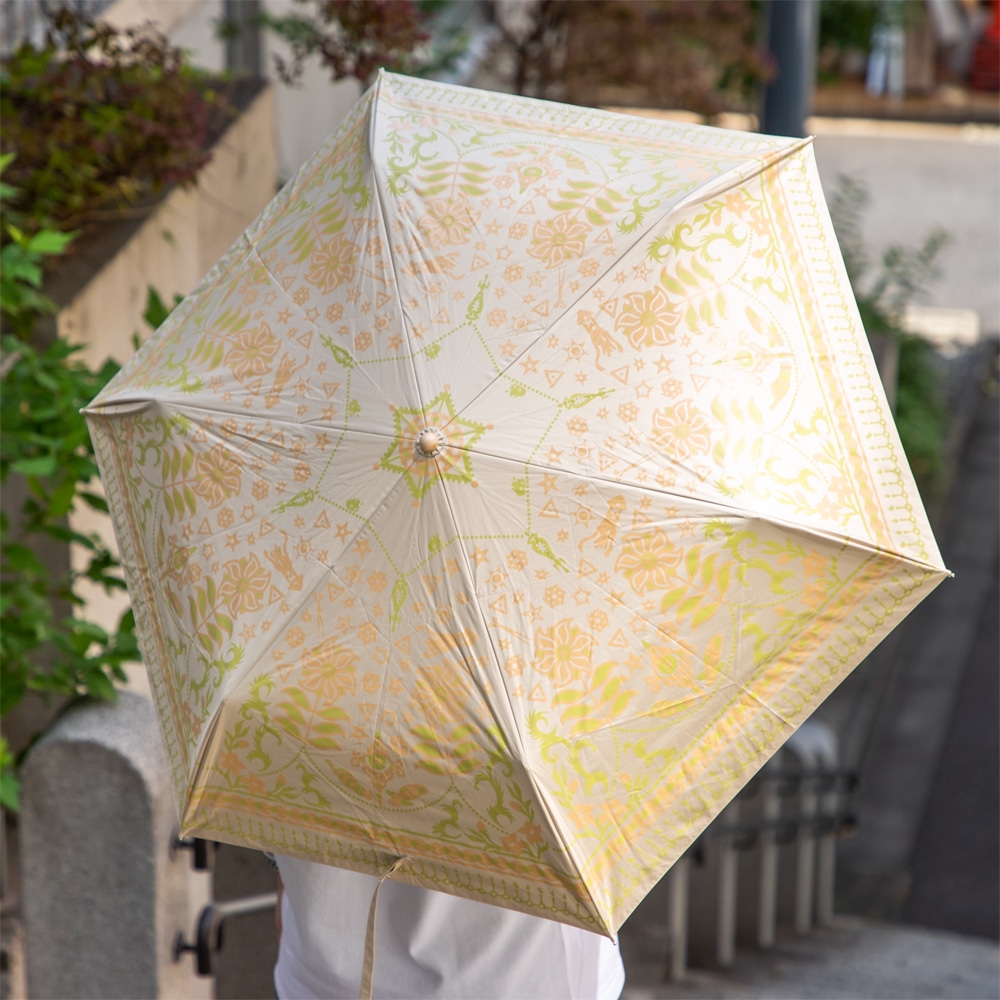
[87,73,946,934]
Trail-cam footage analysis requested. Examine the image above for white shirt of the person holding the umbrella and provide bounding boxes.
[274,857,625,1000]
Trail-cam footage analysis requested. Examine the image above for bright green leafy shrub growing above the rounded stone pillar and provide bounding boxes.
[0,155,139,809]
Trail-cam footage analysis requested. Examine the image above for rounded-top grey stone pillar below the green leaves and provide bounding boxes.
[20,691,212,1000]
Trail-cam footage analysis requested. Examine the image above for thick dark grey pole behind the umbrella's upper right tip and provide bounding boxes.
[760,0,819,136]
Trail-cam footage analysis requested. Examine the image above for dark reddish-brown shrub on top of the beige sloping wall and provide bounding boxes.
[0,8,220,232]
